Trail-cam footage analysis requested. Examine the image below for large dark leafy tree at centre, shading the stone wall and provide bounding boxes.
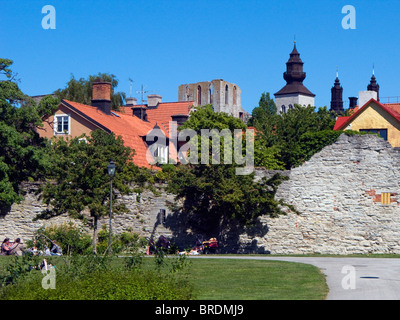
[167,105,292,235]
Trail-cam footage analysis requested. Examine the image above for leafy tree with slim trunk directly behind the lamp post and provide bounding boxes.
[38,130,150,252]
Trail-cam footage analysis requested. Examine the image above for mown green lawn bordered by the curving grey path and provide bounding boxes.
[190,259,328,300]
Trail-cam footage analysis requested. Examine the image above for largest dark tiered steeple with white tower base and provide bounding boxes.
[274,41,315,113]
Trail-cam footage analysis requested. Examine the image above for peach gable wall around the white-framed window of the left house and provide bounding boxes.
[37,104,97,139]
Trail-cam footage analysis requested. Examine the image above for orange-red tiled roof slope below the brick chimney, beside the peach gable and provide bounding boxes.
[61,100,156,169]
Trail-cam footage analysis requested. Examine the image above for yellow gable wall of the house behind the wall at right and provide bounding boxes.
[344,102,400,147]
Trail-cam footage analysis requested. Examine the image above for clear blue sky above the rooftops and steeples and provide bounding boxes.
[0,0,400,112]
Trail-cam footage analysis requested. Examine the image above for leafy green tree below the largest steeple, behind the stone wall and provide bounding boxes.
[249,93,338,169]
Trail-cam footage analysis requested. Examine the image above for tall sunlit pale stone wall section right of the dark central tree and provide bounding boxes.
[242,135,400,254]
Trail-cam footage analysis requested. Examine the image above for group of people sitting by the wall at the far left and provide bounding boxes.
[0,238,62,256]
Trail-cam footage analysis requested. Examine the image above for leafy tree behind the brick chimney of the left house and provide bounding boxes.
[54,72,125,110]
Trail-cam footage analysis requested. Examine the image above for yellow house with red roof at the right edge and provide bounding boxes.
[333,99,400,147]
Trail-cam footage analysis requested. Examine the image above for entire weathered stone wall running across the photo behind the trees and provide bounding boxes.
[0,135,400,254]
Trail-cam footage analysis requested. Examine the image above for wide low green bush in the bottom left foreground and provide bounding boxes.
[0,255,192,300]
